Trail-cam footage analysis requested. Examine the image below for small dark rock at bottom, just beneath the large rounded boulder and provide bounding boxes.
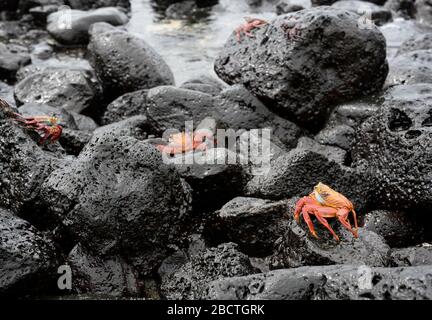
[67,245,140,297]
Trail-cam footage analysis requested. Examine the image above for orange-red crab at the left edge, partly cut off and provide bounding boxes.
[0,99,63,145]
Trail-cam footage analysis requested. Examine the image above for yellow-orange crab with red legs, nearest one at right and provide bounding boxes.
[294,182,358,241]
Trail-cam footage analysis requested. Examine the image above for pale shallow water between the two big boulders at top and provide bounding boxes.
[128,0,286,84]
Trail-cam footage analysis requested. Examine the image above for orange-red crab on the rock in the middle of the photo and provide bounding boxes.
[156,130,213,155]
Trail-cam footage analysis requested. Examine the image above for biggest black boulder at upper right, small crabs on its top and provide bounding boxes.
[215,7,388,131]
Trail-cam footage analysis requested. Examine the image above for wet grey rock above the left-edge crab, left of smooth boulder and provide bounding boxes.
[15,69,101,112]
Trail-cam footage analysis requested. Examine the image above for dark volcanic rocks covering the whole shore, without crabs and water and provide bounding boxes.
[0,0,432,300]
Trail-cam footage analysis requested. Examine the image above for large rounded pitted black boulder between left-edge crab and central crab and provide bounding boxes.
[42,133,190,274]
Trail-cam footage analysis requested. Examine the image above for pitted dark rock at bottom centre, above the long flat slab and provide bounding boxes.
[161,243,256,300]
